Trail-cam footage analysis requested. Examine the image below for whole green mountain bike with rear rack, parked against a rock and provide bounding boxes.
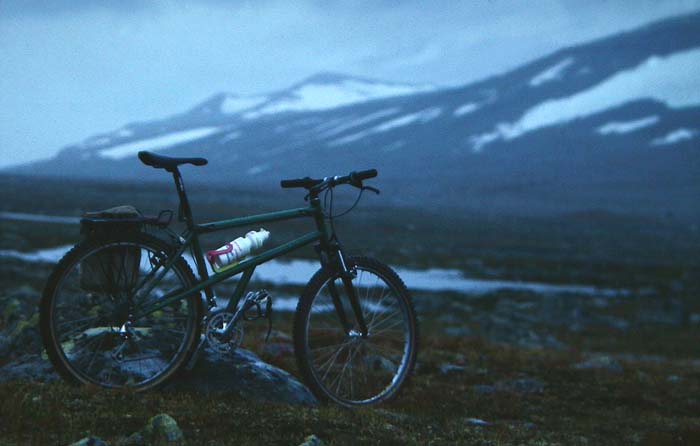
[40,151,418,407]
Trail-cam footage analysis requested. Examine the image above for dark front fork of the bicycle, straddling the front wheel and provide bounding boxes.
[316,241,368,338]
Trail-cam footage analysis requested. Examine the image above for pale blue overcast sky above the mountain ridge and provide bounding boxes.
[0,0,700,168]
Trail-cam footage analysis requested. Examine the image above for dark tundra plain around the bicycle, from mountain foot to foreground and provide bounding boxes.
[0,179,700,445]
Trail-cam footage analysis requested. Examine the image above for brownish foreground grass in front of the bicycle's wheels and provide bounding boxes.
[0,338,700,445]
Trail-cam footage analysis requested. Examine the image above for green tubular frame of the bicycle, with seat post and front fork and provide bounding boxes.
[132,169,367,335]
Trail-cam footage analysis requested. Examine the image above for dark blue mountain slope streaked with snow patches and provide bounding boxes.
[10,14,700,218]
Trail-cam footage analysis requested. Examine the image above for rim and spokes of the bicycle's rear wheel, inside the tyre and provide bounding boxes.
[51,242,196,388]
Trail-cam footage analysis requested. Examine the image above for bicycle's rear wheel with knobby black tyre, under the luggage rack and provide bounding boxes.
[40,233,203,391]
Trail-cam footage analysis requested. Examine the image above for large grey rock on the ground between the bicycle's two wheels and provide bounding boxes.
[167,347,318,406]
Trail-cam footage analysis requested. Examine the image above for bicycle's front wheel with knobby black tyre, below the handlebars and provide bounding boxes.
[294,257,418,407]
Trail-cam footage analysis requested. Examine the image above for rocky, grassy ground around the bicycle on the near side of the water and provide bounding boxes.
[0,247,700,445]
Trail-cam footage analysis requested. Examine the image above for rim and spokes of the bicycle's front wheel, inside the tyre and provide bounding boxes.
[306,266,413,405]
